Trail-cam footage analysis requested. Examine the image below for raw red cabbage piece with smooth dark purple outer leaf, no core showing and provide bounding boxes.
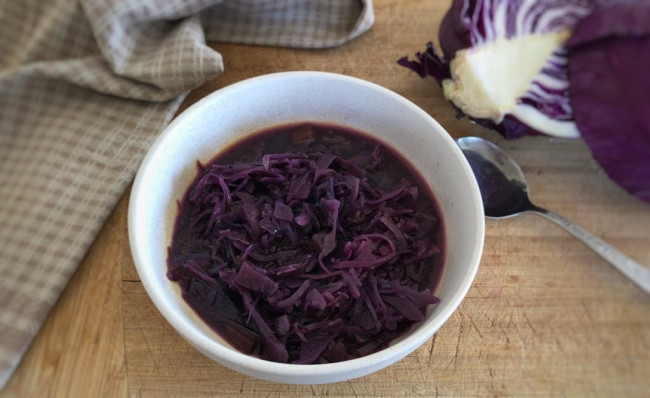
[567,1,650,201]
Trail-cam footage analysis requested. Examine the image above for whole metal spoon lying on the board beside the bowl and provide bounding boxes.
[456,137,650,294]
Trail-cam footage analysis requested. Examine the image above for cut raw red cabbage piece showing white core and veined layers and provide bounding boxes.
[398,0,593,138]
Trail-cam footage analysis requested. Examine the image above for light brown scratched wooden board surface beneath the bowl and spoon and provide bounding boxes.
[0,0,650,398]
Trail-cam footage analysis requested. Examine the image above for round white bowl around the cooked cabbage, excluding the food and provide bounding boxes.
[128,72,484,384]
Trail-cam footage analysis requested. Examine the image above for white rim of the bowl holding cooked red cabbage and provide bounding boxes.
[127,71,485,378]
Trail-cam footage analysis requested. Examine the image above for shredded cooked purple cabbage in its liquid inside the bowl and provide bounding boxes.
[167,124,442,364]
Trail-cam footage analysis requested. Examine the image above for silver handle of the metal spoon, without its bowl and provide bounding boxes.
[535,207,650,294]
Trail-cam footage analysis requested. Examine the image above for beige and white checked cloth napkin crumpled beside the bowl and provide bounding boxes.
[0,0,373,388]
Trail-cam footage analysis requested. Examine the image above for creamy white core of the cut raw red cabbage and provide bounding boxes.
[442,29,579,137]
